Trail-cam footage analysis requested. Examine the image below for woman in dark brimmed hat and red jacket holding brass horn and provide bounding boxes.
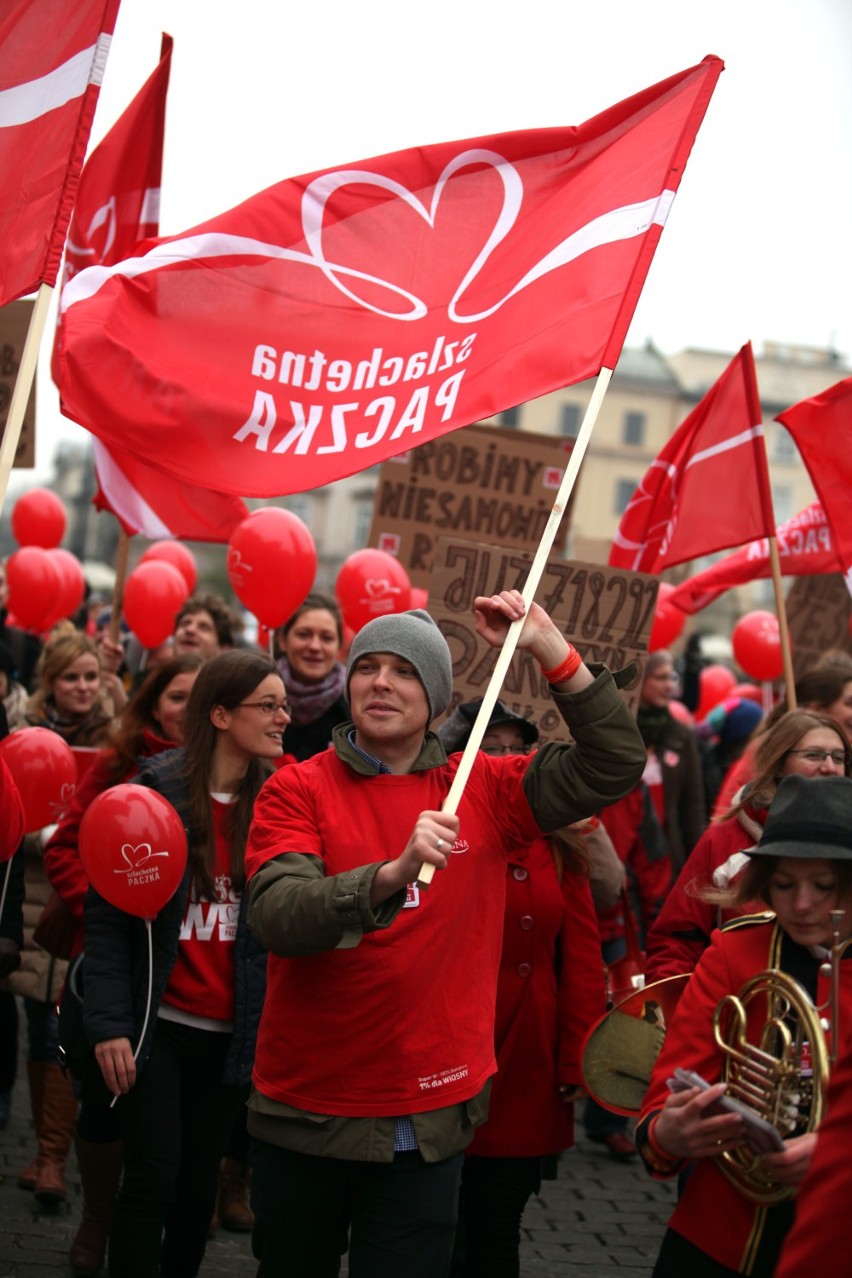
[636,776,852,1278]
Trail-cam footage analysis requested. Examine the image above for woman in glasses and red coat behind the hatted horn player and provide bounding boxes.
[645,711,849,983]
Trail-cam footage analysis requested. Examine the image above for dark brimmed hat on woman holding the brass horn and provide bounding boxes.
[749,777,852,860]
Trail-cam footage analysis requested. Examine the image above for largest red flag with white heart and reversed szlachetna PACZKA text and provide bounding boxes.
[56,58,722,496]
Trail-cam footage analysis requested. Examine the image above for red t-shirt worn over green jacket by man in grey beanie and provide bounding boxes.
[247,750,540,1117]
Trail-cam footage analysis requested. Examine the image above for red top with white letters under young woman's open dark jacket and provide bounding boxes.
[162,795,240,1022]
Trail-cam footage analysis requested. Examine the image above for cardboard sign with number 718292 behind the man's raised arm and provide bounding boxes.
[429,537,659,744]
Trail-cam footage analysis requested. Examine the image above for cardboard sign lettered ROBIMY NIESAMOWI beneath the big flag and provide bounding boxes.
[369,426,576,588]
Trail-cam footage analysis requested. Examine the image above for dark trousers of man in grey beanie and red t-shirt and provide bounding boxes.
[252,1140,464,1278]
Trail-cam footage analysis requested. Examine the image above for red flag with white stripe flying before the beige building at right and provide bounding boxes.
[609,343,775,573]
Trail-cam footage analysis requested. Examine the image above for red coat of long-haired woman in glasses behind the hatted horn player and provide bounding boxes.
[645,808,763,985]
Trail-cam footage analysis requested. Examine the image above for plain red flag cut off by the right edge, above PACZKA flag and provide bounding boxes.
[775,377,852,593]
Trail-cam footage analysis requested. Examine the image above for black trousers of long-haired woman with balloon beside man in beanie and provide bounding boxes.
[110,1020,245,1278]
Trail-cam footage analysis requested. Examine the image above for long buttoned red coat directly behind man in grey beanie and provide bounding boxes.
[468,838,604,1158]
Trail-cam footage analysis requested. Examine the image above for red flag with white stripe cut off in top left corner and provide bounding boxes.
[0,0,119,305]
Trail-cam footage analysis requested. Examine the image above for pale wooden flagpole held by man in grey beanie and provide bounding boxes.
[416,368,613,887]
